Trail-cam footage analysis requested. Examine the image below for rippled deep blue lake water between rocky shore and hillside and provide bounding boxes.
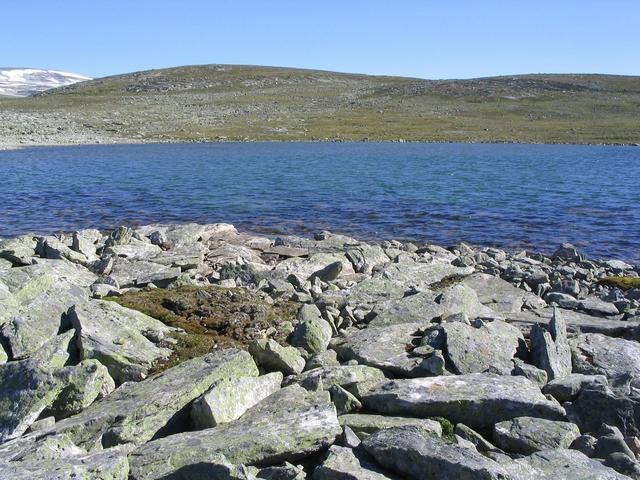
[0,143,640,262]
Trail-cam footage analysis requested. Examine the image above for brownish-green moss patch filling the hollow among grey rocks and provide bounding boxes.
[107,286,300,372]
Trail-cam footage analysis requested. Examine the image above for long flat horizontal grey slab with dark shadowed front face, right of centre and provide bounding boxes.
[354,373,565,429]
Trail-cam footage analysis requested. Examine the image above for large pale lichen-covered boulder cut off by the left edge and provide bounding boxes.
[0,259,96,360]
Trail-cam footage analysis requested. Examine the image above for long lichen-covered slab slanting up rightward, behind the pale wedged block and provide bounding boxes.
[38,349,258,450]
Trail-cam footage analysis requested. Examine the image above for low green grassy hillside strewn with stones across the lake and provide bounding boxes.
[0,65,640,143]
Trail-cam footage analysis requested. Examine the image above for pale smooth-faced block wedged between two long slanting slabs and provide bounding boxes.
[191,372,283,429]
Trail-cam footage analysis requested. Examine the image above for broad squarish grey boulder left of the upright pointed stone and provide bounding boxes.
[425,320,527,375]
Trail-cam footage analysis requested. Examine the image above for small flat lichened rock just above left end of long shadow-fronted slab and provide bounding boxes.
[288,365,385,390]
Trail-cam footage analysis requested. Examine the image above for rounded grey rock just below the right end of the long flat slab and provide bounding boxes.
[493,417,580,455]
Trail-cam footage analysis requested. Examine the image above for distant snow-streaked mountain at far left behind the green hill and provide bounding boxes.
[0,68,91,97]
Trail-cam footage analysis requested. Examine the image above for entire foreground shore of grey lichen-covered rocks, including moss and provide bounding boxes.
[0,224,640,480]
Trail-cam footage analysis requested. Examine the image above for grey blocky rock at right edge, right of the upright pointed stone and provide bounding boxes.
[569,333,640,387]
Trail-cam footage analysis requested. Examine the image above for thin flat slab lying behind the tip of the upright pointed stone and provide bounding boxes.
[501,307,640,337]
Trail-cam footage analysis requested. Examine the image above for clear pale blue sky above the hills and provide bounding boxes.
[0,0,640,78]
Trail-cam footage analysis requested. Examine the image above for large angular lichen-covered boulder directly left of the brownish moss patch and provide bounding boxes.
[70,300,175,384]
